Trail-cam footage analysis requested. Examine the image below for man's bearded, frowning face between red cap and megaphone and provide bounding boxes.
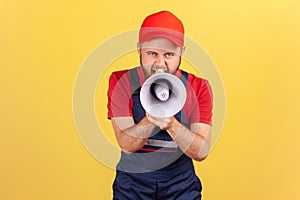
[139,37,183,77]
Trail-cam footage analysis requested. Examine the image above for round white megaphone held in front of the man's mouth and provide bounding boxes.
[140,72,186,118]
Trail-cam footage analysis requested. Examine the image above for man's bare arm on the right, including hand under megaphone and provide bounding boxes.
[147,115,211,161]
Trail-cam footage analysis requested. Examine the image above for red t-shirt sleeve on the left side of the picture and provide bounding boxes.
[107,71,132,119]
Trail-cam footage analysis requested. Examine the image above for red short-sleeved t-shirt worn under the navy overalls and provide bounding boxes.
[107,67,213,125]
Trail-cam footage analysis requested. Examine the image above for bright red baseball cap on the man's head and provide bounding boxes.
[139,10,184,47]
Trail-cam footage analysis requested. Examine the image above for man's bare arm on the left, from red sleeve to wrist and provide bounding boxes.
[111,117,155,153]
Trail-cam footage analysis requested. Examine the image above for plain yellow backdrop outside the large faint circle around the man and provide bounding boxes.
[0,0,300,200]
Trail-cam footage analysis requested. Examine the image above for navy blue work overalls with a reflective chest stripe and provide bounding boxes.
[113,68,202,200]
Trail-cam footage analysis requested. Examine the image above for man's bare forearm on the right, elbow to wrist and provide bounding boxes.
[167,120,210,161]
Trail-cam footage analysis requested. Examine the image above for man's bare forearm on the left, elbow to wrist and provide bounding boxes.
[117,117,155,153]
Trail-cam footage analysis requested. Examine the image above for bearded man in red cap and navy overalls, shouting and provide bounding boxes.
[108,11,212,200]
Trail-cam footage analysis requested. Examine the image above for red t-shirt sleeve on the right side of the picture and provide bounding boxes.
[190,79,213,125]
